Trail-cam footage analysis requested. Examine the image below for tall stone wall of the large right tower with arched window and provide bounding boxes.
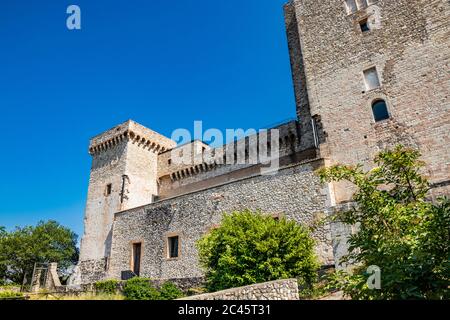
[286,0,450,203]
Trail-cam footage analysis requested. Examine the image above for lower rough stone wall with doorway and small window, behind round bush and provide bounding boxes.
[108,159,334,279]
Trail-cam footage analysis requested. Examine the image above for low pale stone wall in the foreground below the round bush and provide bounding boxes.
[180,279,299,300]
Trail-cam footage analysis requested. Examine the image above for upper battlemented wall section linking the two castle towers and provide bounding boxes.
[158,121,316,199]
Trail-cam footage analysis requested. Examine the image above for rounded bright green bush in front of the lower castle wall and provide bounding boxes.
[197,210,319,291]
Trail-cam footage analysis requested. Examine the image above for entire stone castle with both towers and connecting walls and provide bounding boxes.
[73,0,450,283]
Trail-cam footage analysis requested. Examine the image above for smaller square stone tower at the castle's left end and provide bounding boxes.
[80,120,176,276]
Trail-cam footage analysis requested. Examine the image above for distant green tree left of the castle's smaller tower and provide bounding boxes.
[0,221,78,283]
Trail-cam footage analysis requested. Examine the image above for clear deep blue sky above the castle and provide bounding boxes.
[0,0,295,240]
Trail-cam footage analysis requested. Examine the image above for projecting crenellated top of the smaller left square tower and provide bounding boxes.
[89,120,176,155]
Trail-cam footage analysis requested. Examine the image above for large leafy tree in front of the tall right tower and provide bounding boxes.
[319,146,450,299]
